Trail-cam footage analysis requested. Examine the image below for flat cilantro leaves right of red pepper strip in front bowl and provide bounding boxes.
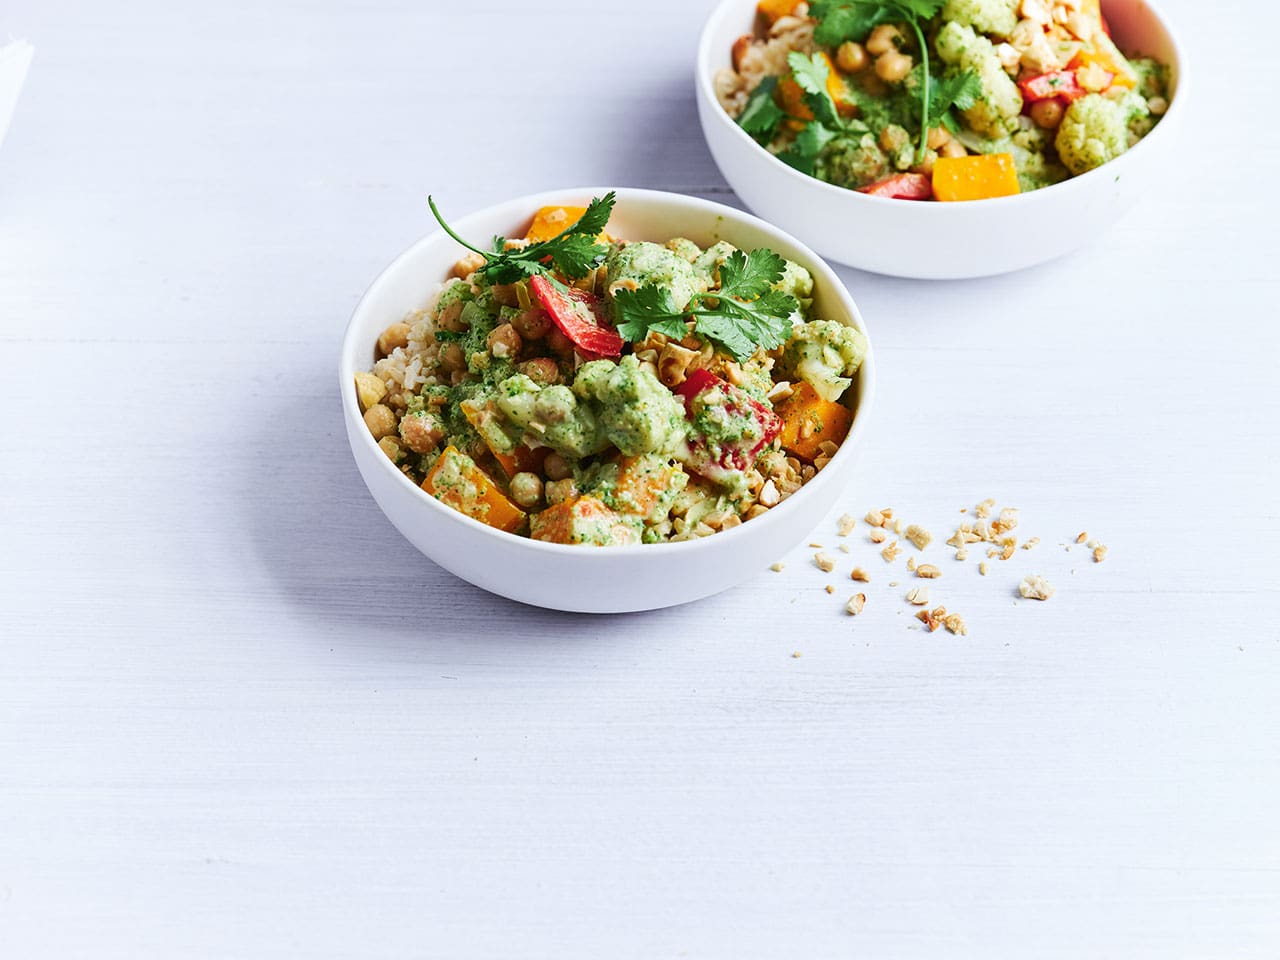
[613,248,800,362]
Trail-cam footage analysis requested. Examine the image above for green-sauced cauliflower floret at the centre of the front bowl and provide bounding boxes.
[573,355,686,457]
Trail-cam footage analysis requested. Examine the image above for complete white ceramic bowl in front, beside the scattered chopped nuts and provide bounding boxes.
[338,187,876,613]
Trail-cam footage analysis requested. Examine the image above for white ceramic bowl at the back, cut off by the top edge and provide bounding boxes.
[696,0,1187,280]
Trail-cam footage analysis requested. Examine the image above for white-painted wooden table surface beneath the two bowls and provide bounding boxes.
[0,0,1280,960]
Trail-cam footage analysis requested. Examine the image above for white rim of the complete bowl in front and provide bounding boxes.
[338,187,876,557]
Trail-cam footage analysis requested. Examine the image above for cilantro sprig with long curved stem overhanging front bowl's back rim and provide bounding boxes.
[426,191,617,283]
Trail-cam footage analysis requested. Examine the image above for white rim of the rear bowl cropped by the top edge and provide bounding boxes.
[696,0,1187,209]
